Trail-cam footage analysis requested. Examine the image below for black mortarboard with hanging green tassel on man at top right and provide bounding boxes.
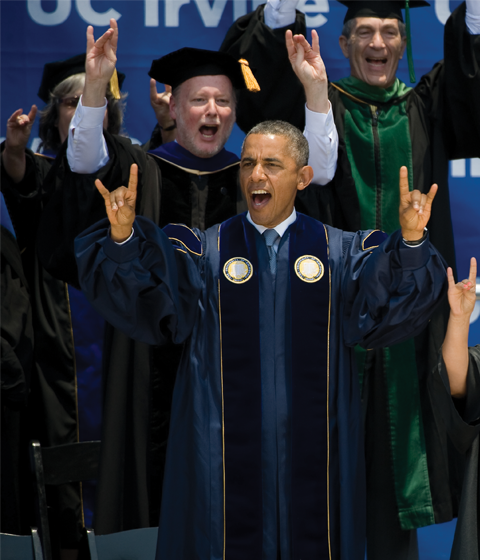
[338,0,430,84]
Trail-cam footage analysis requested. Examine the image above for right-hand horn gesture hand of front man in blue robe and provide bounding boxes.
[400,166,438,241]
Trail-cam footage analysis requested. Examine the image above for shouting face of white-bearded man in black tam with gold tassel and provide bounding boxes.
[170,75,235,158]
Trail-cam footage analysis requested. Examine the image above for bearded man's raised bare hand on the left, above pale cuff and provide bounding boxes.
[82,19,118,107]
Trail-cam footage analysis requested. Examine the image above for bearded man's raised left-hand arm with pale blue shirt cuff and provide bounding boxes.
[67,19,118,173]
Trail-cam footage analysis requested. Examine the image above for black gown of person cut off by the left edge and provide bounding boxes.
[0,195,34,535]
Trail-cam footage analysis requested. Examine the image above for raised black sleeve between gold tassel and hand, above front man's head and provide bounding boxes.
[220,5,306,133]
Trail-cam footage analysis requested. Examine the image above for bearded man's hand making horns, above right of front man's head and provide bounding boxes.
[285,29,330,113]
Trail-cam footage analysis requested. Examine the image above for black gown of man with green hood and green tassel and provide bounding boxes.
[221,0,480,532]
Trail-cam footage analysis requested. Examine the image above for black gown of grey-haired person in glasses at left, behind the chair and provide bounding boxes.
[0,145,103,548]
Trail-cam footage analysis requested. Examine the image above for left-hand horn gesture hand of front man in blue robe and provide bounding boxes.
[95,163,138,242]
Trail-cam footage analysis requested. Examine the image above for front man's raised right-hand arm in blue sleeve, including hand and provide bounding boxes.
[344,167,446,348]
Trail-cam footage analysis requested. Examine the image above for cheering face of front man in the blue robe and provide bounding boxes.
[240,134,313,228]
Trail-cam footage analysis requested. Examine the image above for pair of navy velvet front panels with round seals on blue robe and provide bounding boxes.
[218,217,331,560]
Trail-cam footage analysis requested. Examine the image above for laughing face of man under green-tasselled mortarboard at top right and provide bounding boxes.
[339,17,406,88]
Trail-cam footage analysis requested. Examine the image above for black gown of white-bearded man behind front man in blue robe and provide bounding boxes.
[39,133,243,534]
